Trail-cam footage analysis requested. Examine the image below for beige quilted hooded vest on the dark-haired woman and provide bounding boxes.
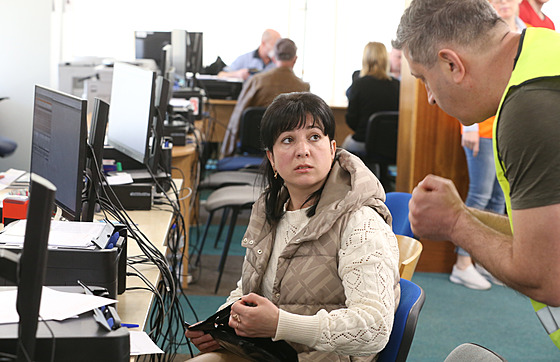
[242,150,392,361]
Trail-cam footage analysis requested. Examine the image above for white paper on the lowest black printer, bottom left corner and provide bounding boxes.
[0,287,117,324]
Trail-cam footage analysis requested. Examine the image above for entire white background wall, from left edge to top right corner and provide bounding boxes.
[0,0,560,170]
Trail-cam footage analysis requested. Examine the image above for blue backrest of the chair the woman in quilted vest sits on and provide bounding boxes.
[377,279,426,362]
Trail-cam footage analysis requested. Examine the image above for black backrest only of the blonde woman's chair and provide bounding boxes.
[365,111,399,164]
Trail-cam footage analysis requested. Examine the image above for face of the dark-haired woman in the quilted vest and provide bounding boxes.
[266,115,336,195]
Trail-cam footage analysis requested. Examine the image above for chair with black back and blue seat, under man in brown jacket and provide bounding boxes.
[217,107,266,171]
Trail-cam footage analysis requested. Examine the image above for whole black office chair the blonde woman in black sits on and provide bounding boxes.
[365,111,399,192]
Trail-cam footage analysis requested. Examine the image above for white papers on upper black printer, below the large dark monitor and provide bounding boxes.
[0,220,106,249]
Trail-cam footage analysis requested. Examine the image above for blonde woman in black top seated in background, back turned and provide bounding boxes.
[342,42,400,157]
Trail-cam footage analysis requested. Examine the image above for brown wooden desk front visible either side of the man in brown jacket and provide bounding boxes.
[199,99,354,146]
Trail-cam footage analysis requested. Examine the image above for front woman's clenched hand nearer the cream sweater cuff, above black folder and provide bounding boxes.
[229,293,279,338]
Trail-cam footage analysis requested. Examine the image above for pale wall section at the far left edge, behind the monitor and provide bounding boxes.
[0,0,53,170]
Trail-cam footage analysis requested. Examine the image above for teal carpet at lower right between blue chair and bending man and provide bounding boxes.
[408,272,560,362]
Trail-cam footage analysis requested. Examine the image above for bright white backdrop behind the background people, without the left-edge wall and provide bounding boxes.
[62,0,404,104]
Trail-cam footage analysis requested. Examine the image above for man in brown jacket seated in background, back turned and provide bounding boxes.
[221,38,309,157]
